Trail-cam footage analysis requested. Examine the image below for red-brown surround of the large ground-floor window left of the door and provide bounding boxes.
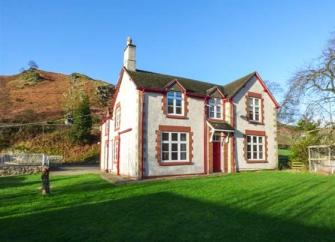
[156,125,193,166]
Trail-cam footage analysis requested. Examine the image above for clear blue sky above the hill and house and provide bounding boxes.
[0,0,335,100]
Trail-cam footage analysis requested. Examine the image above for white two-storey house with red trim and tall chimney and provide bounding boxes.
[101,38,279,179]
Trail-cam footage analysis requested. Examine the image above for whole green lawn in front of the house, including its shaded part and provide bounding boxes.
[0,172,335,242]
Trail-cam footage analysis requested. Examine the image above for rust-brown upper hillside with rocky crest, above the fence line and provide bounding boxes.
[0,69,111,123]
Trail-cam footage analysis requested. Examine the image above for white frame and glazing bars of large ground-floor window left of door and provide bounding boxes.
[160,131,189,163]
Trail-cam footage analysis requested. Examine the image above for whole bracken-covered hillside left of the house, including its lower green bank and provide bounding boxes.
[0,68,114,162]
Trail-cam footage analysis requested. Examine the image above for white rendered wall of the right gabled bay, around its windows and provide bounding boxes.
[233,77,278,171]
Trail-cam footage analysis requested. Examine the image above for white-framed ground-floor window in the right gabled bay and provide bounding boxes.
[246,135,266,161]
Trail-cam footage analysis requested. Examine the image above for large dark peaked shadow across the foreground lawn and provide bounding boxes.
[0,192,335,242]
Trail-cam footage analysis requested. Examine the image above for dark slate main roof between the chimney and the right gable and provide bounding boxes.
[127,70,256,97]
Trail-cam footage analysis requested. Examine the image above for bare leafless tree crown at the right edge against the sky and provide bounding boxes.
[280,34,335,124]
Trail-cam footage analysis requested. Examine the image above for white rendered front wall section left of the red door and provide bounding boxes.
[144,93,204,176]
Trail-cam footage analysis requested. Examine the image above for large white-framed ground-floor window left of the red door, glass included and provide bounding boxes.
[161,132,189,162]
